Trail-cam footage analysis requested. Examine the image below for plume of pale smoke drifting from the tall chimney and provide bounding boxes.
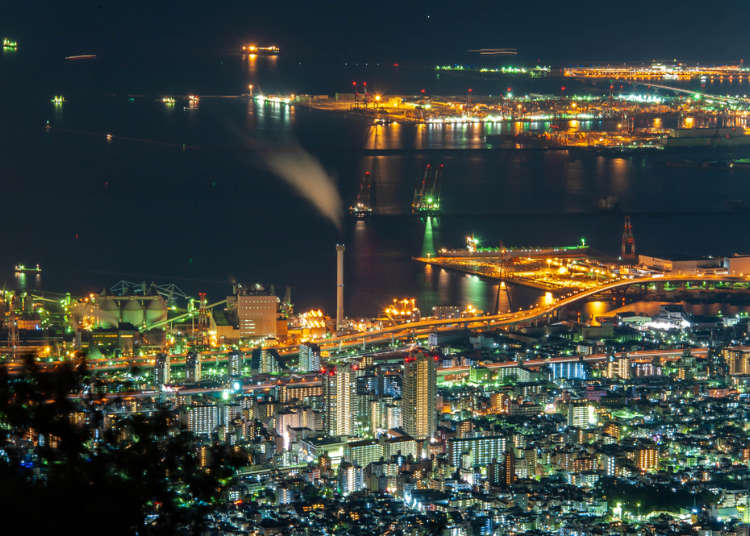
[264,147,343,230]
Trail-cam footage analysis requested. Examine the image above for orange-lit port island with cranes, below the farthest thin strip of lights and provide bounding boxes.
[293,82,750,151]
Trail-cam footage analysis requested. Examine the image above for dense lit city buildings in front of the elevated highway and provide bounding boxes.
[25,306,736,536]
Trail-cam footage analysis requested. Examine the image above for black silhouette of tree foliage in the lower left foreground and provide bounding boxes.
[0,359,246,535]
